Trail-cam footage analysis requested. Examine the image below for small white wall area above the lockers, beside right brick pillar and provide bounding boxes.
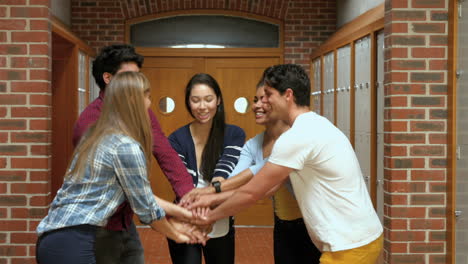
[336,0,384,28]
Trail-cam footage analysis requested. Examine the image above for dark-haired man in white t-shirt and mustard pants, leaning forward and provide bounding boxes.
[195,64,383,264]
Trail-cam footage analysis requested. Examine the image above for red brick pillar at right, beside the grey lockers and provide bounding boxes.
[384,0,449,264]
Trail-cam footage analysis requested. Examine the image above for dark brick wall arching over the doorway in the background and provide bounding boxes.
[72,0,336,70]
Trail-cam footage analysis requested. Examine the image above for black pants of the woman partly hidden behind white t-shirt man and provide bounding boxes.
[273,215,322,264]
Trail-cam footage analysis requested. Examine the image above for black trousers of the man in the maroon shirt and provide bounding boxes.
[91,221,145,264]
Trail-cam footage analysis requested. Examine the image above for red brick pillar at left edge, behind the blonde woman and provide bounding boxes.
[0,0,51,264]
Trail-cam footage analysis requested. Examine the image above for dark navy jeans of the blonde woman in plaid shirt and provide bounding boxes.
[36,225,98,264]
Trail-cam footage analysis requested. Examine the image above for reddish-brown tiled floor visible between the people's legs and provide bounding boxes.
[138,227,273,264]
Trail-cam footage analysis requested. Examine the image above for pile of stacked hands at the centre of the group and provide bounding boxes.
[151,177,224,245]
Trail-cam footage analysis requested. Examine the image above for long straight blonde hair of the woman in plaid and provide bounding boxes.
[65,72,152,179]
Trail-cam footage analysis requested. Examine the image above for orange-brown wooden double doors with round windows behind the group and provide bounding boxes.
[142,57,280,225]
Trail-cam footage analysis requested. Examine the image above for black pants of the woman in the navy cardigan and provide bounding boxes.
[167,219,235,264]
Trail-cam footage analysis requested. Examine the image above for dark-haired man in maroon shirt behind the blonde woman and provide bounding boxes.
[73,45,193,264]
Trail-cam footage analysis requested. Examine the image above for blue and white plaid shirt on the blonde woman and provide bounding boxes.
[37,134,165,235]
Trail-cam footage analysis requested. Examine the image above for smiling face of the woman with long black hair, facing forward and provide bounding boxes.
[189,84,219,124]
